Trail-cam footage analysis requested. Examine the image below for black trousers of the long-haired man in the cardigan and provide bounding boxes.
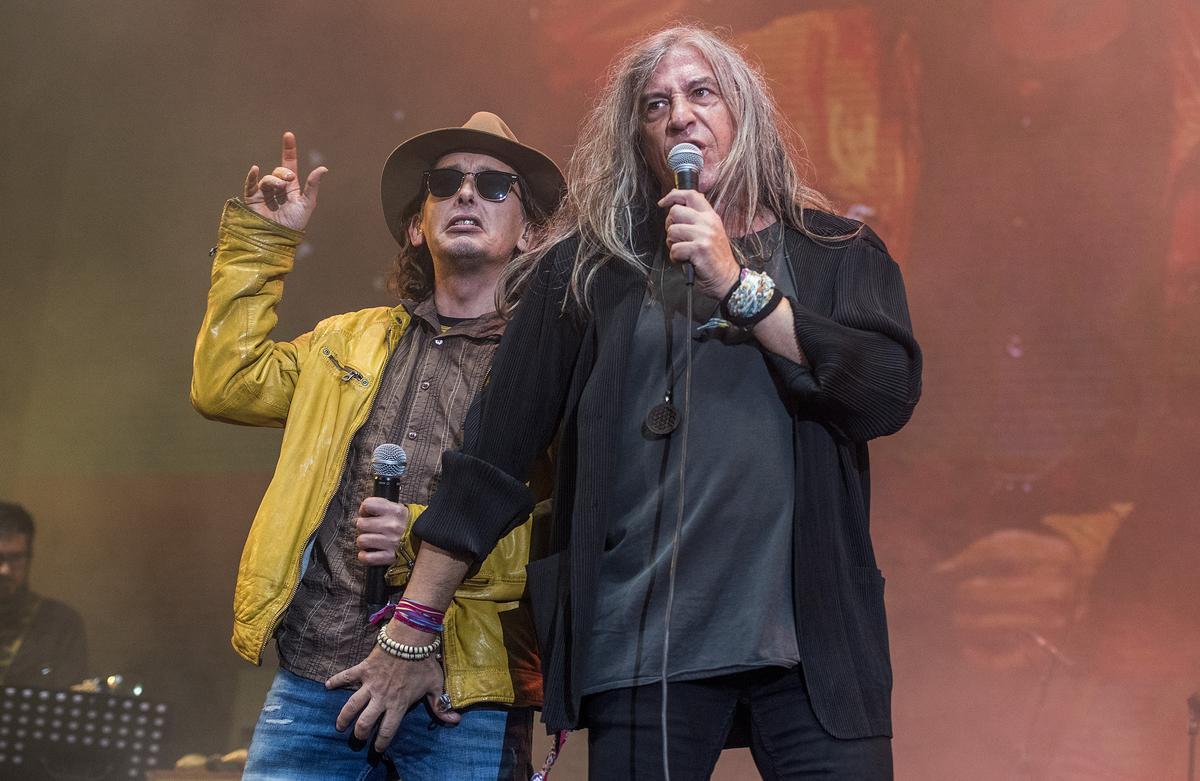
[582,667,892,781]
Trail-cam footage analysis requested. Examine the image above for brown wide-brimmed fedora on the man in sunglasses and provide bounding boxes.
[379,112,566,244]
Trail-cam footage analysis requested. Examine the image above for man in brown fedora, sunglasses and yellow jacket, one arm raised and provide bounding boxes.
[192,112,563,780]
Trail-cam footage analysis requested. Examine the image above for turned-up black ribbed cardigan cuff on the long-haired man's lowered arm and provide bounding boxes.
[409,451,533,561]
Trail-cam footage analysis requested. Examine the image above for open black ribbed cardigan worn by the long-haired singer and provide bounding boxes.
[413,211,922,738]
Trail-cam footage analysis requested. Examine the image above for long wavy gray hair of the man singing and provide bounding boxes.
[497,26,832,311]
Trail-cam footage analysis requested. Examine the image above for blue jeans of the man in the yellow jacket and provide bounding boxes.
[242,669,533,781]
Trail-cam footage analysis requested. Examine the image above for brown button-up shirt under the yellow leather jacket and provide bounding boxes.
[276,296,505,681]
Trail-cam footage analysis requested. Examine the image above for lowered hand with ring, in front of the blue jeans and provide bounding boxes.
[325,648,460,753]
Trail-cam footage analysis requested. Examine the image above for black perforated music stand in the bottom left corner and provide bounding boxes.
[0,686,169,781]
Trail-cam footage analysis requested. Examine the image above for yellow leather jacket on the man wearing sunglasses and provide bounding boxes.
[192,200,541,708]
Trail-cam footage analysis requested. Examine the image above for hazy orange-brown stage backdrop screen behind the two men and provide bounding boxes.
[0,0,1200,781]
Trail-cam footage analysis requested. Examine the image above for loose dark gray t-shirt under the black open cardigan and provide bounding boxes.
[581,226,799,695]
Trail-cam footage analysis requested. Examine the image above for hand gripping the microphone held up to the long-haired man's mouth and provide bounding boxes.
[659,190,742,301]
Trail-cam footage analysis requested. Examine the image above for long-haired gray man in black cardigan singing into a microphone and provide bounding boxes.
[333,28,920,780]
